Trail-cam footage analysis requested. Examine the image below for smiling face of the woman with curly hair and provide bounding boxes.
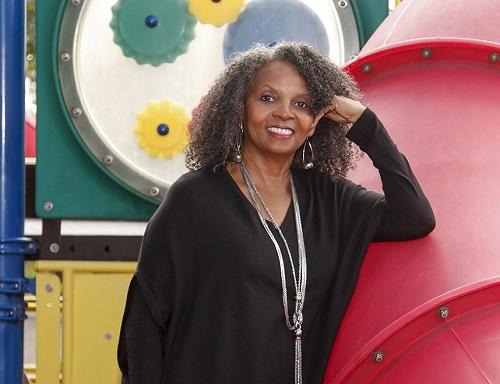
[243,61,314,159]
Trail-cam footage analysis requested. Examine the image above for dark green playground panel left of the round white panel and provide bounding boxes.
[35,0,158,220]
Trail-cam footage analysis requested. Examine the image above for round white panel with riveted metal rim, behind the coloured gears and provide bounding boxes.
[55,0,359,202]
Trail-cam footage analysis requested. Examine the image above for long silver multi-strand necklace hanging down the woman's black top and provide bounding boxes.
[240,161,307,384]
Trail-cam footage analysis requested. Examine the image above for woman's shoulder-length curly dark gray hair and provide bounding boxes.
[186,42,360,177]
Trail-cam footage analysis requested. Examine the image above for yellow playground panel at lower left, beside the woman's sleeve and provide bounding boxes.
[35,260,136,384]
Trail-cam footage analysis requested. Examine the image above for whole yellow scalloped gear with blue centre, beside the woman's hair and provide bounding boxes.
[134,99,190,159]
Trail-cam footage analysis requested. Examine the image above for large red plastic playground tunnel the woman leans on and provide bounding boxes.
[324,0,500,384]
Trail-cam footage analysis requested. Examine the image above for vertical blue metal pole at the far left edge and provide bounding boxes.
[0,0,29,384]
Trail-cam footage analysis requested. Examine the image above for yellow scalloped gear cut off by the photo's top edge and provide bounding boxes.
[188,0,245,27]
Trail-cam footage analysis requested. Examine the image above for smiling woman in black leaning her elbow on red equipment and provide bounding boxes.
[119,43,435,384]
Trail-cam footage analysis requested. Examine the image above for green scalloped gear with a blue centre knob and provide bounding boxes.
[109,0,196,67]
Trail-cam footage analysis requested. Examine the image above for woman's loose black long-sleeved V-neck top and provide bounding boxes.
[118,109,435,384]
